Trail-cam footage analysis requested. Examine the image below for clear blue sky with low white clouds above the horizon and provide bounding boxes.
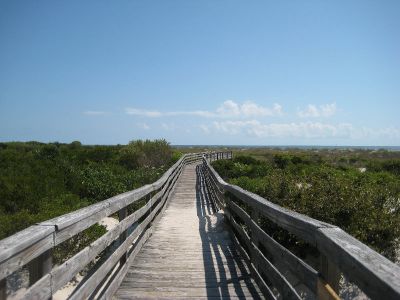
[0,0,400,145]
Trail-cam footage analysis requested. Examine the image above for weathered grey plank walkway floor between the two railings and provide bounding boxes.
[114,164,263,299]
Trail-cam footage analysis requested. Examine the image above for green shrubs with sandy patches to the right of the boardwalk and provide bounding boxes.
[213,150,400,260]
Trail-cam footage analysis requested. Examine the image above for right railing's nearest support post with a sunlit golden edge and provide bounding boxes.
[316,253,340,300]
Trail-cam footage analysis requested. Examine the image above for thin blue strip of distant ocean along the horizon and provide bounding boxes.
[172,145,400,151]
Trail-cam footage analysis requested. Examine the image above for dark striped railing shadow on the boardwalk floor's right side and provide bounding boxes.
[196,165,260,299]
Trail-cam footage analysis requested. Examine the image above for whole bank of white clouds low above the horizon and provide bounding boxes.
[85,100,400,141]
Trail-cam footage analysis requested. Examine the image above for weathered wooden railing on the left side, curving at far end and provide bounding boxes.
[0,152,227,299]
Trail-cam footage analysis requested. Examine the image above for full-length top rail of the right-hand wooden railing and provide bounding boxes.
[203,159,400,299]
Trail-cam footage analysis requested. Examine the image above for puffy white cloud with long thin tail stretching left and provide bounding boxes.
[125,100,282,118]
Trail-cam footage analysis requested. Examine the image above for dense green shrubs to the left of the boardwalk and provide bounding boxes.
[0,140,180,245]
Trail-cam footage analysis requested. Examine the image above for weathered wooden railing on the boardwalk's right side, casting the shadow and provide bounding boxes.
[203,156,400,299]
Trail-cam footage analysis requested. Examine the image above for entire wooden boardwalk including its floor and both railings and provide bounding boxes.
[0,152,400,299]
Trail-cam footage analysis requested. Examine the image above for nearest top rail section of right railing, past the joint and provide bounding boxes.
[316,228,400,299]
